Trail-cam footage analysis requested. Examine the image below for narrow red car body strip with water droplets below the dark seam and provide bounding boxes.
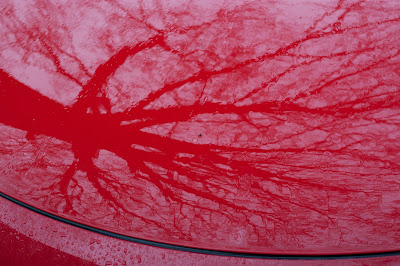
[4,195,400,266]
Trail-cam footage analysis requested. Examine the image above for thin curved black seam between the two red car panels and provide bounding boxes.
[0,192,400,260]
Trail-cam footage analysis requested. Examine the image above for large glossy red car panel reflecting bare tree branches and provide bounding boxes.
[0,0,400,255]
